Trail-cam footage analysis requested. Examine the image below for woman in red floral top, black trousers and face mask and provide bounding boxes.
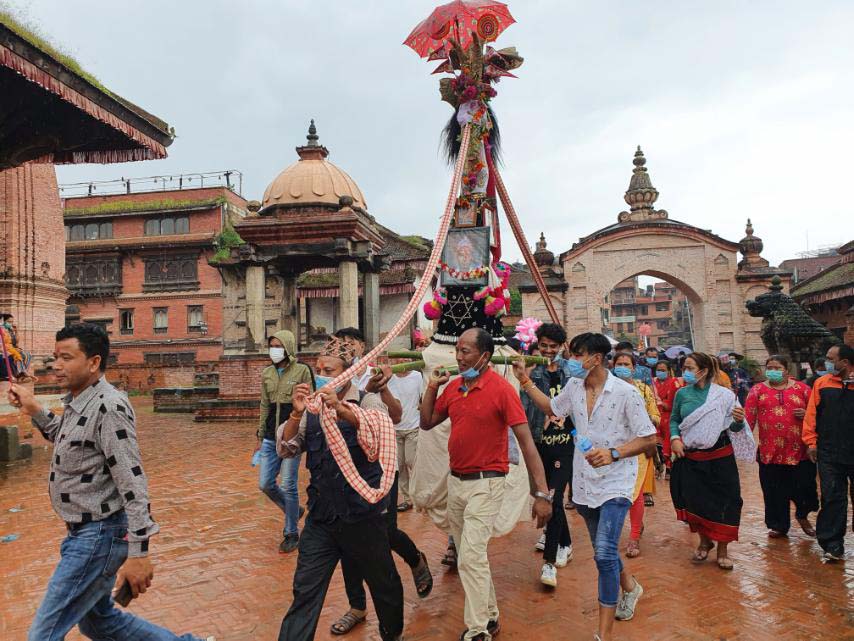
[744,355,818,538]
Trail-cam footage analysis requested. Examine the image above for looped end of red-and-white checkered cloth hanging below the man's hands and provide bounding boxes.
[306,396,397,509]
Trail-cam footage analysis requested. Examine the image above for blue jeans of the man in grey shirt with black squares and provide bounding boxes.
[27,512,206,641]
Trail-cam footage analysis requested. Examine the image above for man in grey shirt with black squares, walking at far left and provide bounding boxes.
[9,323,213,641]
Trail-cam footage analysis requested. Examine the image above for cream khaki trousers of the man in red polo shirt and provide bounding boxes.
[448,475,505,640]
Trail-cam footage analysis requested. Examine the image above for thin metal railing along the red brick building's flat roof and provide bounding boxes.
[59,169,243,198]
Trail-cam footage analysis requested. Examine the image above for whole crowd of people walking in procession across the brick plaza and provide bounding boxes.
[9,323,854,641]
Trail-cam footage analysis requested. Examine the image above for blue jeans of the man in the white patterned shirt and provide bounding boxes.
[576,497,632,608]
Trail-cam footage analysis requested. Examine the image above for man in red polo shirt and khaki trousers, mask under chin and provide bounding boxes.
[421,328,552,641]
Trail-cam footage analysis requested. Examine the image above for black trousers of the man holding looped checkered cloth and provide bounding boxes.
[279,516,403,641]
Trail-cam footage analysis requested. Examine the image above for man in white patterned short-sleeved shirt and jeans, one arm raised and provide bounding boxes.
[513,332,656,641]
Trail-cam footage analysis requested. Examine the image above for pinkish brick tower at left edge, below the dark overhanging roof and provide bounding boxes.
[0,163,68,358]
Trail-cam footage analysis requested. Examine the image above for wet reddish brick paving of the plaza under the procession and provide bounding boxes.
[0,398,854,641]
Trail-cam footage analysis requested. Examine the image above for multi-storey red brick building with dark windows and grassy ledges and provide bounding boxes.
[63,177,246,366]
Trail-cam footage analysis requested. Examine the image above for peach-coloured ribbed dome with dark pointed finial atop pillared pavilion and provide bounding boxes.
[261,120,367,210]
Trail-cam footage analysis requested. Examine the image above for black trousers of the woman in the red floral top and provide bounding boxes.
[759,461,818,534]
